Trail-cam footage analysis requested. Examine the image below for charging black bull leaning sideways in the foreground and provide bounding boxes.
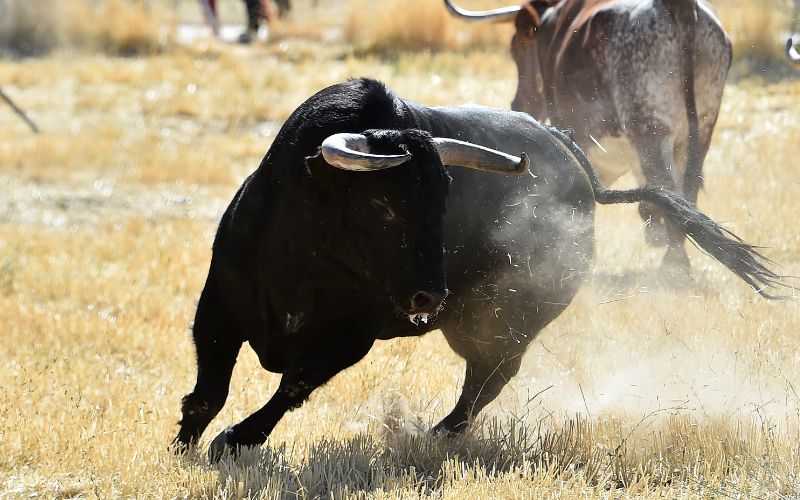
[176,79,780,457]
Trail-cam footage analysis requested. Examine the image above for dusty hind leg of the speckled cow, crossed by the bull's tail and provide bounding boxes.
[631,127,690,275]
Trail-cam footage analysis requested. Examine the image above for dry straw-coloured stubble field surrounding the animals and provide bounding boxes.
[0,0,800,498]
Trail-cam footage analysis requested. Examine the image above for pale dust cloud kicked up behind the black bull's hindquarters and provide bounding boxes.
[478,151,800,426]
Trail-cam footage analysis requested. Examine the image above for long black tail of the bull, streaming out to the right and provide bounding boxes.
[548,127,794,299]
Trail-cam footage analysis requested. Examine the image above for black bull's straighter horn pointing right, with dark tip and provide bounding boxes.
[433,137,529,175]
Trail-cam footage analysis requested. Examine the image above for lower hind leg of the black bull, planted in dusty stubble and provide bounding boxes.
[432,354,522,434]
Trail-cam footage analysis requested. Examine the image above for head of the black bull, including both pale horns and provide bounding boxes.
[309,129,528,322]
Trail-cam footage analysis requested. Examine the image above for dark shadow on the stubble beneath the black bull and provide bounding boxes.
[196,424,580,498]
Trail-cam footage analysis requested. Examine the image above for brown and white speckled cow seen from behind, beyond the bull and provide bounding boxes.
[445,0,731,270]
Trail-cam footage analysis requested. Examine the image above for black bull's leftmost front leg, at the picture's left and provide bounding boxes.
[173,280,242,451]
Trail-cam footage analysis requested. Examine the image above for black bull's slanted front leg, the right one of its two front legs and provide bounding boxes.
[208,338,374,461]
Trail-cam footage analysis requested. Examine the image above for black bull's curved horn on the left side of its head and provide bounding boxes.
[321,134,411,172]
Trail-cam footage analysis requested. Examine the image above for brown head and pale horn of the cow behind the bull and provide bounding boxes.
[444,0,558,120]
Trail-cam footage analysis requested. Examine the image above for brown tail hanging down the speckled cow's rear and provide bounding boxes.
[665,0,703,202]
